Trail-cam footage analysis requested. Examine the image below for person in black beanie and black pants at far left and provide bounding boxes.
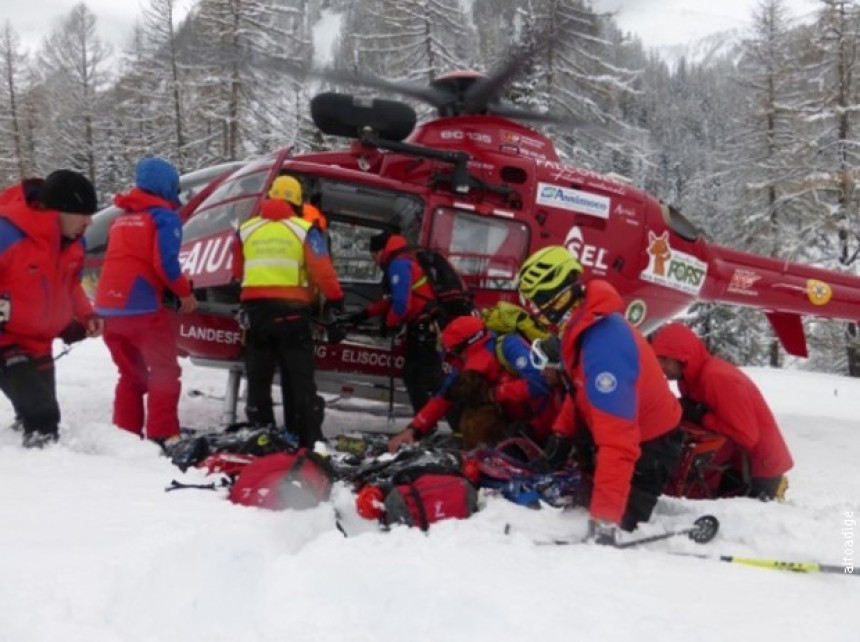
[0,170,103,448]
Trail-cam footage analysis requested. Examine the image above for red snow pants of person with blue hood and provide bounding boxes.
[104,310,182,439]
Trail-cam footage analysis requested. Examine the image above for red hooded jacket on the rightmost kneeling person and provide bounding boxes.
[652,323,794,478]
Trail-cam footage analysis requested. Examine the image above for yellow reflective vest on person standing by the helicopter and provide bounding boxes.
[239,216,311,288]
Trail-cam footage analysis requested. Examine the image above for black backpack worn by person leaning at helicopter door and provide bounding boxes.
[397,246,475,328]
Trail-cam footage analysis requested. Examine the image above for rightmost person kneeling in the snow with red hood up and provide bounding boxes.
[651,323,794,499]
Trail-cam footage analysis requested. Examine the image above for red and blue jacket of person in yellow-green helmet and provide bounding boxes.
[553,280,681,524]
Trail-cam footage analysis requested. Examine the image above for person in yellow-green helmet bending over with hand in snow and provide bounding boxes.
[519,246,682,544]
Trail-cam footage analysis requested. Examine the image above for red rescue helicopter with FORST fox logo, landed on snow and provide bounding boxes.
[80,64,860,422]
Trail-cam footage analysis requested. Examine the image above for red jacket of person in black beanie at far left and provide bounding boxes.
[0,184,93,356]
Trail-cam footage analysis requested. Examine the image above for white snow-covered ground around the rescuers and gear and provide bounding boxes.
[0,340,860,642]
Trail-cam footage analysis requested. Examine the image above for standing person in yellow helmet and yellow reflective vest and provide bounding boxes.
[233,176,343,448]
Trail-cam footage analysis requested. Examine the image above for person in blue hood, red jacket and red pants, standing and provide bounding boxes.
[96,158,197,449]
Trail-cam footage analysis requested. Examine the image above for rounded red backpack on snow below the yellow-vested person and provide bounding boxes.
[228,448,333,510]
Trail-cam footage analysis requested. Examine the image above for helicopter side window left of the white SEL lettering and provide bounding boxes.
[430,209,529,290]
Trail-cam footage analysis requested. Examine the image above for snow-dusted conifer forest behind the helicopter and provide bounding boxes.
[0,0,860,376]
